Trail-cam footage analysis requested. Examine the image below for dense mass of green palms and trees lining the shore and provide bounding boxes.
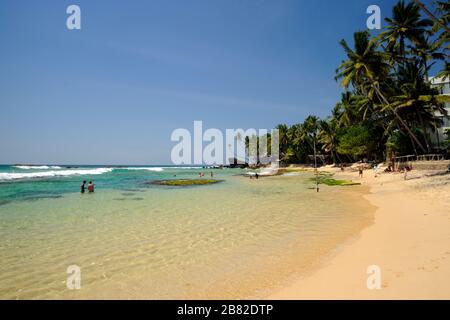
[248,0,450,164]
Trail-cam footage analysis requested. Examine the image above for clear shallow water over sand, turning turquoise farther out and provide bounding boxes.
[0,168,373,299]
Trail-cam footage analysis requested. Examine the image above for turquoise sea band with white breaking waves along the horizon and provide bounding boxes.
[0,165,214,205]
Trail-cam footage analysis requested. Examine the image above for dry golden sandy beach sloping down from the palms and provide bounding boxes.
[267,168,450,299]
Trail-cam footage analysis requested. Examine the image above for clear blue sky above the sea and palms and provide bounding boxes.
[0,0,438,164]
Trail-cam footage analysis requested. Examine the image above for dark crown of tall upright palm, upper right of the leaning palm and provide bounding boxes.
[381,0,433,62]
